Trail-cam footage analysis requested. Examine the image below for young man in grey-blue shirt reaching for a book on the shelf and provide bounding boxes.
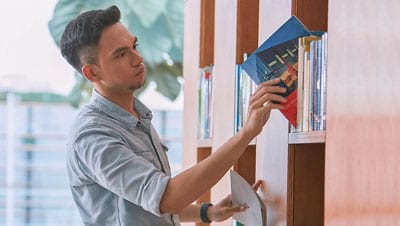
[61,6,286,226]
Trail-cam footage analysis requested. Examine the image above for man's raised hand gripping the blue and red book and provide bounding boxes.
[243,78,286,137]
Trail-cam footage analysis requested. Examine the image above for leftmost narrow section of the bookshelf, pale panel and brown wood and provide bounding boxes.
[183,0,215,226]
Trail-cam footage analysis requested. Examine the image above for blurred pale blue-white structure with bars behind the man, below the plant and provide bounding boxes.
[0,94,182,226]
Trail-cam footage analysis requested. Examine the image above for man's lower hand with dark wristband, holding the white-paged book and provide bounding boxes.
[207,180,262,222]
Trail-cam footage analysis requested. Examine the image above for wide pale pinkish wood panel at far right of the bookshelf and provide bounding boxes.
[325,0,400,226]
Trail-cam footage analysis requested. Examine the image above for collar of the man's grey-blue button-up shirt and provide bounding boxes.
[89,89,153,128]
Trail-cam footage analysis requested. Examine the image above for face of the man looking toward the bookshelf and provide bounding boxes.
[94,23,145,93]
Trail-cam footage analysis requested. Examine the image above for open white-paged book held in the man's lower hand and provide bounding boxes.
[230,170,267,226]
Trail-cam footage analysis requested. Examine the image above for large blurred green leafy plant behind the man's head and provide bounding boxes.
[48,0,184,106]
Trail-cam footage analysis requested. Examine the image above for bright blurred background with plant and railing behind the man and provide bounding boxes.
[0,0,183,226]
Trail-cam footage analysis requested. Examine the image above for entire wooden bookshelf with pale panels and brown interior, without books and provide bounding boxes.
[183,0,400,225]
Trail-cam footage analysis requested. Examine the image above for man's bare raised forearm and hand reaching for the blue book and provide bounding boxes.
[160,78,286,214]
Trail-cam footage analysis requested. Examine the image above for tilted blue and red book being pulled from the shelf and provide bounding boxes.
[241,16,312,127]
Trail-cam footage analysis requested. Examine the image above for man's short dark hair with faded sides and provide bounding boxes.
[60,6,121,72]
